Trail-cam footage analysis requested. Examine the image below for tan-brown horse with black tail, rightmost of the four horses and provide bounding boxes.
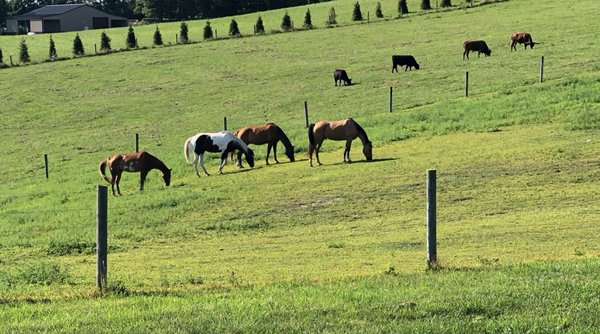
[308,118,373,167]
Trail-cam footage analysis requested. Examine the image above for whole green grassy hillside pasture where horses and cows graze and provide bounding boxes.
[0,0,600,333]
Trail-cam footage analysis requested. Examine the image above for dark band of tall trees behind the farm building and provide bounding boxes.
[0,0,329,25]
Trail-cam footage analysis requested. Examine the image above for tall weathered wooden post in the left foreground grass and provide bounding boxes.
[96,185,108,290]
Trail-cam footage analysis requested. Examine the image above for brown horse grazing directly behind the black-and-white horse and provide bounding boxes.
[232,123,295,167]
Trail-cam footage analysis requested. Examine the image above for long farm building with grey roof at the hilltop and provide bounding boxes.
[6,4,127,33]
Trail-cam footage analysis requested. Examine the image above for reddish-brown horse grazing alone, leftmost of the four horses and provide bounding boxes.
[99,151,171,196]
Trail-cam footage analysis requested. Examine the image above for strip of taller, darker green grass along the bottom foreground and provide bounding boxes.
[0,258,600,333]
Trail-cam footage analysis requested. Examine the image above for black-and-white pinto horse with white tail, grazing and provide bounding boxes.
[183,131,254,177]
